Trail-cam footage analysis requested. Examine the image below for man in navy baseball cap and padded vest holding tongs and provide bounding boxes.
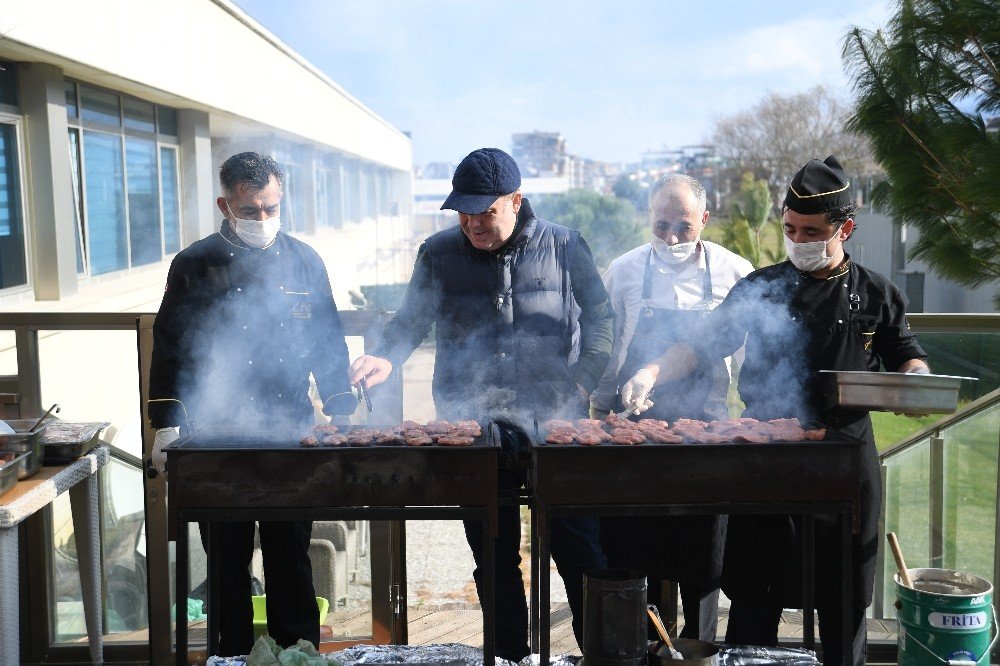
[350,143,615,662]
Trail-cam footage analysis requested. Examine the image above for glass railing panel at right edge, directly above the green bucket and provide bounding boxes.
[941,404,1000,580]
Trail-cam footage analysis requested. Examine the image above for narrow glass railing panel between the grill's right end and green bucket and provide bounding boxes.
[883,440,931,618]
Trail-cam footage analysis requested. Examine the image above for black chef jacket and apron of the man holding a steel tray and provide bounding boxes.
[702,258,927,608]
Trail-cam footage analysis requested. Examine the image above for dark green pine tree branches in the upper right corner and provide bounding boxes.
[843,0,1000,307]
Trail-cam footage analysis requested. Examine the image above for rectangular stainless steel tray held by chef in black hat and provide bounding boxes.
[819,370,977,414]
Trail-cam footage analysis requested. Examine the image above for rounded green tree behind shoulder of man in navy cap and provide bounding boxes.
[531,190,647,272]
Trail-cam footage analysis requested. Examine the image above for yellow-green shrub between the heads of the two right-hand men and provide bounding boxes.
[715,172,785,268]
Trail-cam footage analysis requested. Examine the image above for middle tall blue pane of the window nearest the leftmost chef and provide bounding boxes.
[125,137,161,266]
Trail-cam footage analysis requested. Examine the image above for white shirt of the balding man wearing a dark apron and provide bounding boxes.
[590,240,754,411]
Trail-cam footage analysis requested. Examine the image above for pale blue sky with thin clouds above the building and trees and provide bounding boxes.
[235,0,892,165]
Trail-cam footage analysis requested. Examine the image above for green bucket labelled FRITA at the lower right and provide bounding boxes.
[895,569,996,666]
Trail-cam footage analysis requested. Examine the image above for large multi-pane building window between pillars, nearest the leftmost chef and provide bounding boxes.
[66,81,182,275]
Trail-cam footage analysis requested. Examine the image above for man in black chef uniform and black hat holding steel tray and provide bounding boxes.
[635,156,929,666]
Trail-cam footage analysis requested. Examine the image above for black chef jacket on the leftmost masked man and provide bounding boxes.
[149,222,357,429]
